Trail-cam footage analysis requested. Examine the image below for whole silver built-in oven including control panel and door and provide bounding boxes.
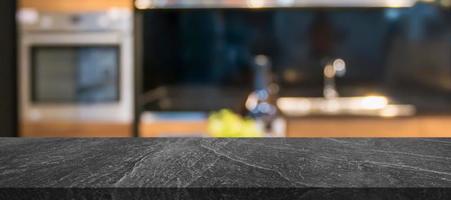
[19,9,133,126]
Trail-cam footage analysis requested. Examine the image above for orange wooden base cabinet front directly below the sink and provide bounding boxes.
[288,116,451,137]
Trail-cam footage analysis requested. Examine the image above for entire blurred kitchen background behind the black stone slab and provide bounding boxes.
[0,0,451,137]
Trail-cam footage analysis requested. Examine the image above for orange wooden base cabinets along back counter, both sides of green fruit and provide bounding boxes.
[139,116,451,137]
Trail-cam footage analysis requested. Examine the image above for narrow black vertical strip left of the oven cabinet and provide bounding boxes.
[0,0,17,137]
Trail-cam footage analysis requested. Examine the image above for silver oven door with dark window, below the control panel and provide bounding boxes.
[20,32,132,122]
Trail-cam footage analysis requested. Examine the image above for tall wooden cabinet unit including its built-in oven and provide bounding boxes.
[17,0,133,137]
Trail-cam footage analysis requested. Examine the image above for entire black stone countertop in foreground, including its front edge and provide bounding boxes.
[0,138,451,200]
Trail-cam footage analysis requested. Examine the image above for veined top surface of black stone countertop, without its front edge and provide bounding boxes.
[0,138,451,187]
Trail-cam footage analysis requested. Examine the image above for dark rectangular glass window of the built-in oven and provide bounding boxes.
[31,46,119,103]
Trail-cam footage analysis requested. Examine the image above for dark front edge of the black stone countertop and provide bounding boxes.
[0,188,451,200]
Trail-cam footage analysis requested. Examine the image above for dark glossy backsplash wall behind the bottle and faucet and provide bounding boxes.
[136,3,451,114]
